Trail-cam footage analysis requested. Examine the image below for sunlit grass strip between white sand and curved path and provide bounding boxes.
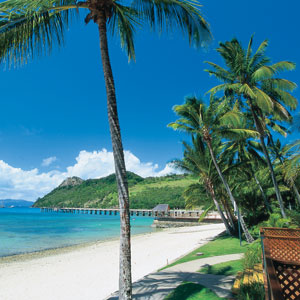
[161,235,248,270]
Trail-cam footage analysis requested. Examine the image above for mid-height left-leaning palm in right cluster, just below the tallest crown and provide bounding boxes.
[168,97,257,242]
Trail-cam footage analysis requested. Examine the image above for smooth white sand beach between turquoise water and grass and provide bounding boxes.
[0,224,224,300]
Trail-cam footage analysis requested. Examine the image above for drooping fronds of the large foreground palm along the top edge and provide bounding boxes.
[0,0,211,63]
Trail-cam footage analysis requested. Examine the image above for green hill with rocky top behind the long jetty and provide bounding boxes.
[34,172,195,209]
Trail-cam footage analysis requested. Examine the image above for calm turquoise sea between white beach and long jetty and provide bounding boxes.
[0,208,155,256]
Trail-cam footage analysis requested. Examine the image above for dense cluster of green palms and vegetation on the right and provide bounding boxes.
[169,37,300,242]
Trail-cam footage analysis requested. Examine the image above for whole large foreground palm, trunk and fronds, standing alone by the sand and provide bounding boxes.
[0,0,210,299]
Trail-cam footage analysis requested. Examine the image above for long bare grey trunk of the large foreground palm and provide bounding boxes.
[97,11,132,300]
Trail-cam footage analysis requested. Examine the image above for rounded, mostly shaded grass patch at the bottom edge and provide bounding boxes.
[164,282,224,300]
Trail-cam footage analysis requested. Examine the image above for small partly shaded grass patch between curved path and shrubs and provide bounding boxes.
[199,259,244,276]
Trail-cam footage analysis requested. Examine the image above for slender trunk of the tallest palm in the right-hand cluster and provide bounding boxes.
[248,104,286,218]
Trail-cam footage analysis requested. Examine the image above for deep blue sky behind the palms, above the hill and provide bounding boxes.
[0,0,300,199]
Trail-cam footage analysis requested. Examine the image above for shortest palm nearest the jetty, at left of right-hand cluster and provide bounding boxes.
[173,134,235,234]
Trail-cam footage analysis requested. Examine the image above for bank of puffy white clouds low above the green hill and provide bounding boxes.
[0,149,180,200]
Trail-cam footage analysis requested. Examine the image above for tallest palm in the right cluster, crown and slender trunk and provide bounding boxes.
[206,37,297,218]
